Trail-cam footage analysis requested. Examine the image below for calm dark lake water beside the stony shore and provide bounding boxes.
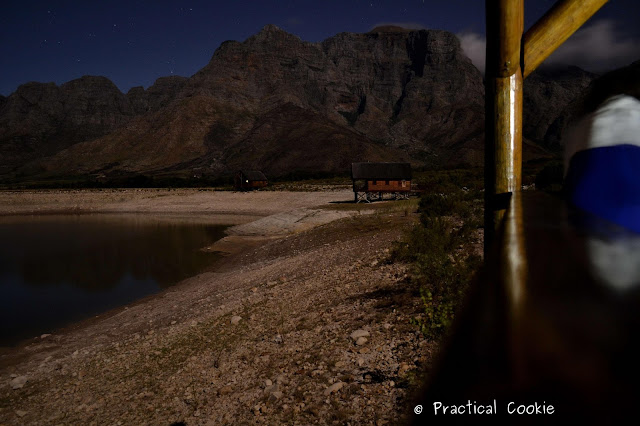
[0,215,226,346]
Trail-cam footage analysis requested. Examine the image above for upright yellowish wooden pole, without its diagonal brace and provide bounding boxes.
[484,0,524,251]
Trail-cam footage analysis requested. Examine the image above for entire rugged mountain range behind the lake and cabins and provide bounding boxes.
[0,25,592,181]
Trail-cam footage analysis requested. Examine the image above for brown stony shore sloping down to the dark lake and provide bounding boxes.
[0,192,436,425]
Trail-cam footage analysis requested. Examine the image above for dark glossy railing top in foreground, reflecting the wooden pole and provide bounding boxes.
[416,191,640,425]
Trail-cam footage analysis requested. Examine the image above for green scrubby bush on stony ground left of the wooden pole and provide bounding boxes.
[392,172,482,339]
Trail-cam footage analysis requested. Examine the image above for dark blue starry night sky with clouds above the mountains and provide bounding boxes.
[0,0,640,96]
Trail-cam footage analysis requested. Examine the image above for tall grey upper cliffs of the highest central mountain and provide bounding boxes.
[183,26,484,164]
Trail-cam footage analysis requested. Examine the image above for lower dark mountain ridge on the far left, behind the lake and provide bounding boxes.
[0,76,186,173]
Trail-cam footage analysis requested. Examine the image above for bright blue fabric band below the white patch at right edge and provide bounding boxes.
[564,144,640,233]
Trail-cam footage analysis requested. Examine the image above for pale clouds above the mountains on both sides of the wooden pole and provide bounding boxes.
[457,20,640,73]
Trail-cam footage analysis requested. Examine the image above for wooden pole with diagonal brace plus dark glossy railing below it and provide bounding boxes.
[415,0,640,424]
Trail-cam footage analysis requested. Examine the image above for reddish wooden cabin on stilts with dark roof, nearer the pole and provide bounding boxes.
[351,163,411,203]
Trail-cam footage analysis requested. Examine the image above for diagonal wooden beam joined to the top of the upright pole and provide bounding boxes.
[523,0,608,78]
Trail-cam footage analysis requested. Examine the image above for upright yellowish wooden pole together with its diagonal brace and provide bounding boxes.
[484,0,607,251]
